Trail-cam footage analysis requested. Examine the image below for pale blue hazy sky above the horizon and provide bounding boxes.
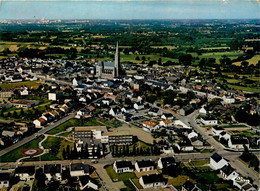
[0,0,260,20]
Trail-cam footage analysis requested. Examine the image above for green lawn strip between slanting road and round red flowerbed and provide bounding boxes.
[0,136,44,162]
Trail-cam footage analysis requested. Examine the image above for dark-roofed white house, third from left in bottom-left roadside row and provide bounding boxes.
[43,164,62,181]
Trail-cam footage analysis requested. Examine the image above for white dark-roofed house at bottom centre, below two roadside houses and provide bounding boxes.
[139,174,167,188]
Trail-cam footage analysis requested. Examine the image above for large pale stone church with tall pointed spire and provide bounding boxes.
[96,43,120,79]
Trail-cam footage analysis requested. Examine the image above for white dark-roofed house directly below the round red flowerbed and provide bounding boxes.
[14,166,35,181]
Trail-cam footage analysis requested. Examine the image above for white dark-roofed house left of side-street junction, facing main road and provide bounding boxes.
[70,163,94,177]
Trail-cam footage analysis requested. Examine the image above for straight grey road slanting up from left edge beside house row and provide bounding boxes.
[0,113,75,157]
